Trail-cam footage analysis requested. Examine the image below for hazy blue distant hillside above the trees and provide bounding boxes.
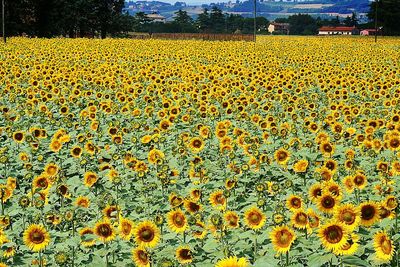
[125,0,370,21]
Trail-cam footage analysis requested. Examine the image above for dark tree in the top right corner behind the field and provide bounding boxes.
[368,0,400,35]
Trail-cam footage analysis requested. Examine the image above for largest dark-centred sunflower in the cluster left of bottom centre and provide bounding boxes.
[133,221,160,248]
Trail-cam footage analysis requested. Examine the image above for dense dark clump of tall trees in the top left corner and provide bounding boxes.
[5,0,127,38]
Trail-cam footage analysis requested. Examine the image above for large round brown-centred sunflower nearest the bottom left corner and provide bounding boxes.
[23,224,50,252]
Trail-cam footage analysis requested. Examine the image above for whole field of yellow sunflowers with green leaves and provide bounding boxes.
[0,36,400,267]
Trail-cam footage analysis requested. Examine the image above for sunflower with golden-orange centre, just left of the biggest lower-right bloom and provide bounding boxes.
[269,225,296,254]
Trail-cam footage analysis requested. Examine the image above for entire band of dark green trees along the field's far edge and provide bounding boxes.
[0,0,400,38]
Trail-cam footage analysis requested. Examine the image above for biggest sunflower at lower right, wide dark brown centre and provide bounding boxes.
[318,222,348,251]
